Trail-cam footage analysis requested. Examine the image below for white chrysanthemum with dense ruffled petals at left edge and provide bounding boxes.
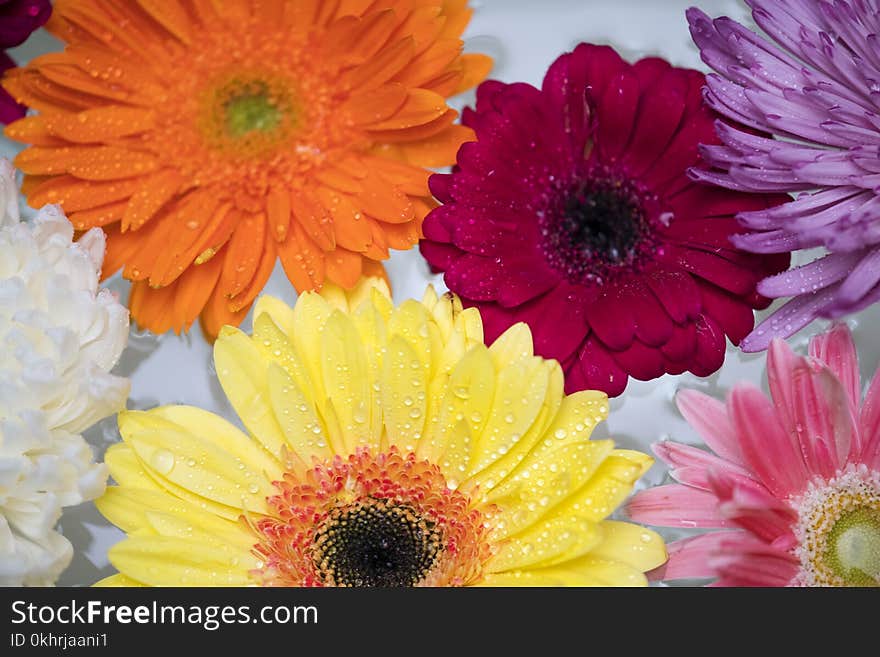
[0,160,129,586]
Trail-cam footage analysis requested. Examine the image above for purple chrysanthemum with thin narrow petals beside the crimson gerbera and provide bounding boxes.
[688,0,880,351]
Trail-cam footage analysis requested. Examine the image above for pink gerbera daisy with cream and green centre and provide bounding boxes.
[629,325,880,586]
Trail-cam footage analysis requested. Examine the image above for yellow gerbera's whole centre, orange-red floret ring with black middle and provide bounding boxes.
[253,447,492,586]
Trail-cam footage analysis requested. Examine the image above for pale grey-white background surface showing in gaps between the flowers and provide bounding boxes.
[0,0,880,585]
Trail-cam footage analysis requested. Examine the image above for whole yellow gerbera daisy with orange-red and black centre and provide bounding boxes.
[98,279,666,586]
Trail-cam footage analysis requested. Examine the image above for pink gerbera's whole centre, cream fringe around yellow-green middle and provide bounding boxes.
[793,465,880,586]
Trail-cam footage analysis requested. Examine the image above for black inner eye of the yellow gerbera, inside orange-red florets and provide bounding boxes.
[314,498,443,587]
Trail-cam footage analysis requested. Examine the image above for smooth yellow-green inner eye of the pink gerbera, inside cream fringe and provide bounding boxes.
[825,507,880,586]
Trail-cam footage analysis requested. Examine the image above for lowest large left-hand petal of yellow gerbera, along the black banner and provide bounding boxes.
[108,536,259,586]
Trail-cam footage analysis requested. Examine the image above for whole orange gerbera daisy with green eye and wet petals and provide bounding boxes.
[4,0,491,337]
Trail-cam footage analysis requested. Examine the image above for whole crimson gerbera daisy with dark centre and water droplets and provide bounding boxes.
[421,44,789,395]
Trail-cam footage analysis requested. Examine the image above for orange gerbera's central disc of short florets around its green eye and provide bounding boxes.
[148,19,365,196]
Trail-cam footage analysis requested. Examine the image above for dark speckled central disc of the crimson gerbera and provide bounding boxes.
[539,165,668,285]
